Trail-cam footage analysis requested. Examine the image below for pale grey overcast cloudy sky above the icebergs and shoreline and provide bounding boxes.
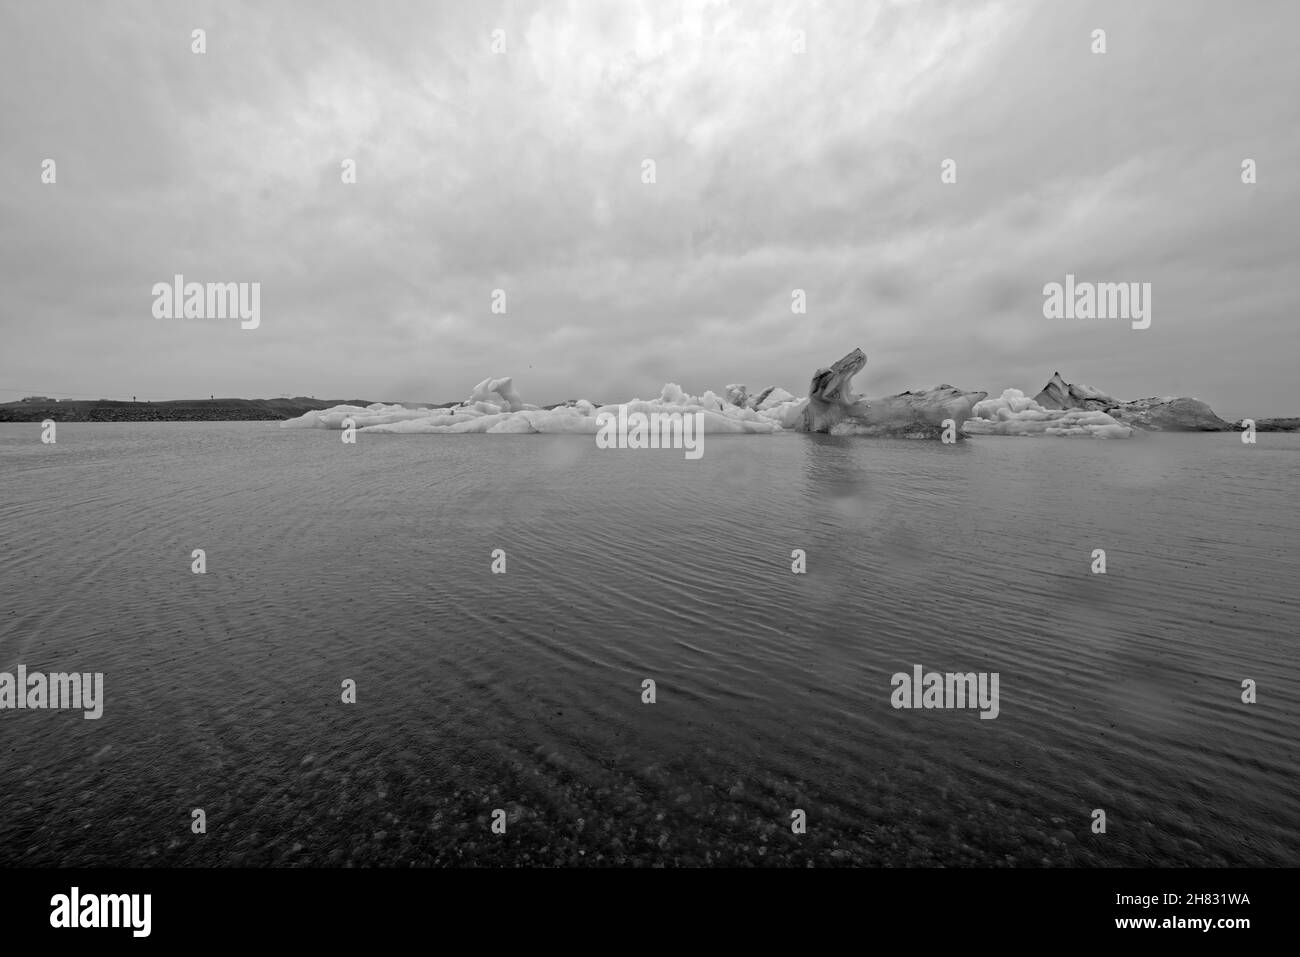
[0,0,1300,417]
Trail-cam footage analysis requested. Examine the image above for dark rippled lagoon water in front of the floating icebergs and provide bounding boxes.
[0,423,1300,866]
